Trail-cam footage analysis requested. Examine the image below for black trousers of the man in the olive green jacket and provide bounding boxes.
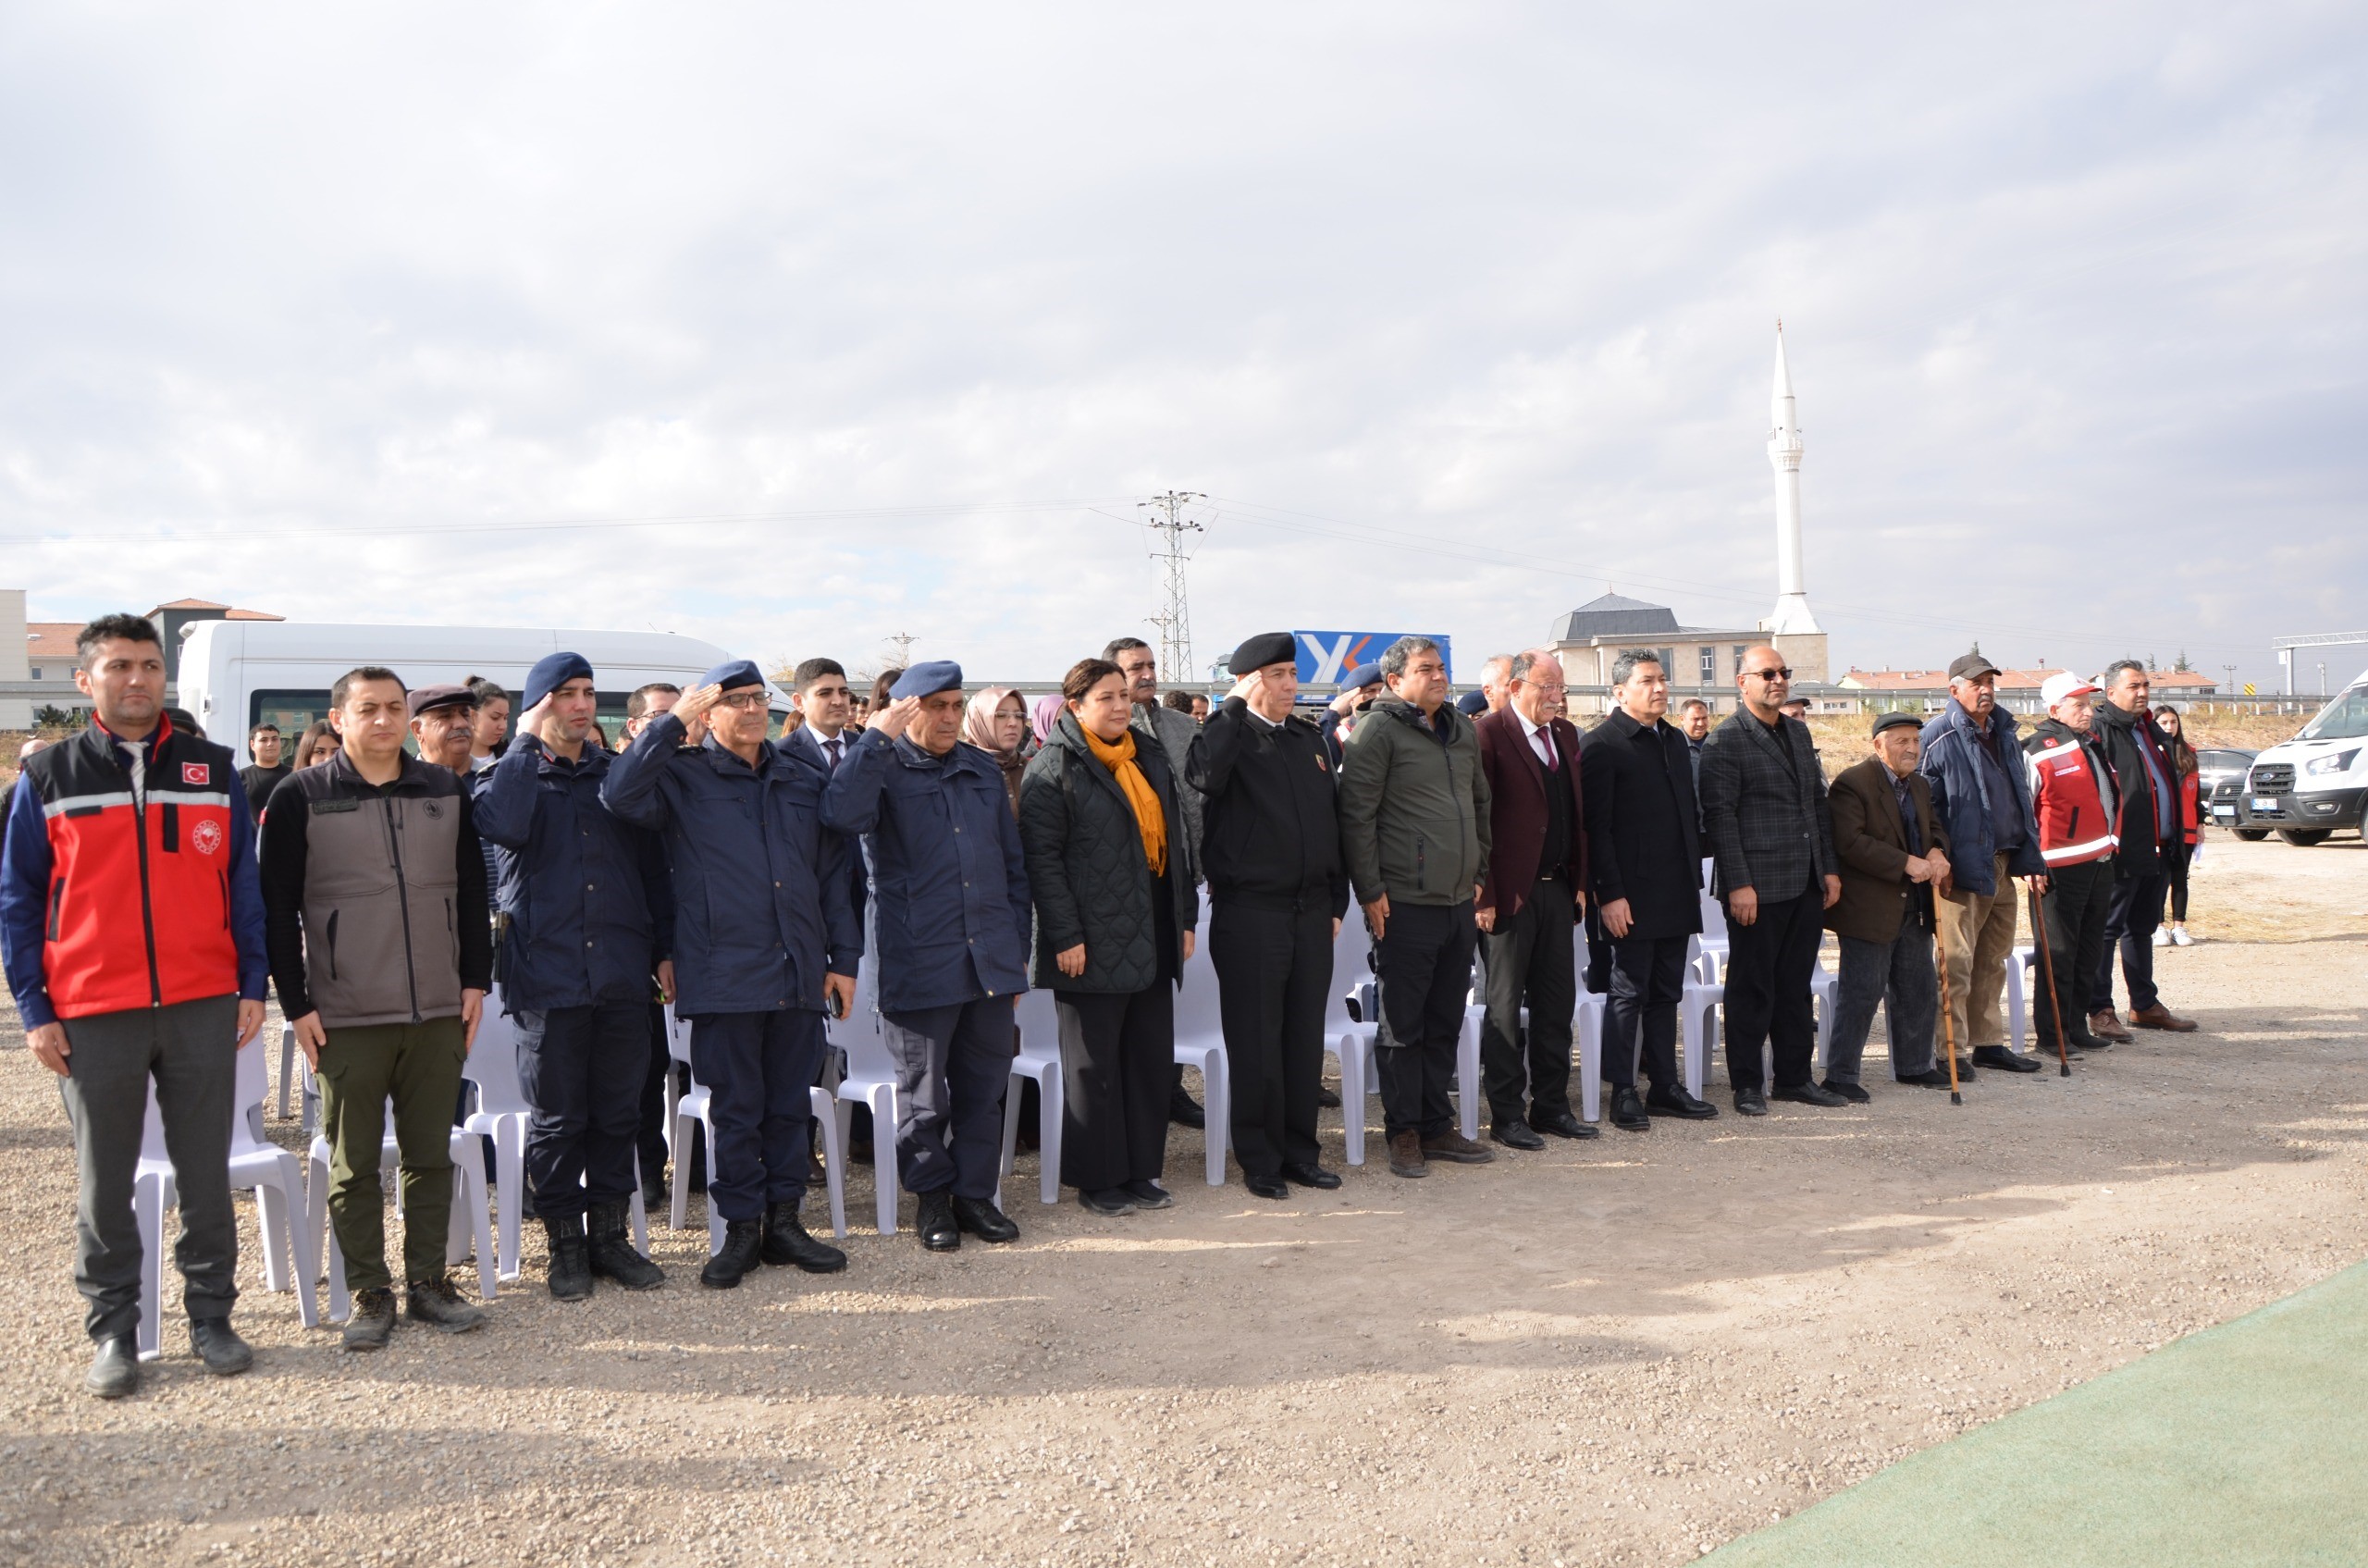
[1375,903,1480,1137]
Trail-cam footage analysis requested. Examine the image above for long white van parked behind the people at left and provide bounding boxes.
[178,621,788,768]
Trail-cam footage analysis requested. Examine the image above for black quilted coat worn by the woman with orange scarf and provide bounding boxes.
[1020,713,1201,994]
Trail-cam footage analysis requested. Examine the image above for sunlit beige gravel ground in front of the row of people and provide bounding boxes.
[0,836,2368,1568]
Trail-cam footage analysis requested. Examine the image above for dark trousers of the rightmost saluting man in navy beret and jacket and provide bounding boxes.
[881,997,1011,1201]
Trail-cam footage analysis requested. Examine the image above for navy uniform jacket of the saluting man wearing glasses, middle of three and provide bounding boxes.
[599,713,864,1019]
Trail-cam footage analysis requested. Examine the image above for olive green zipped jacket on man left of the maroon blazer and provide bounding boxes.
[1340,697,1489,905]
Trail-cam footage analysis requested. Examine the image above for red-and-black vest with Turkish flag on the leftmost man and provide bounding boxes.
[17,720,240,1019]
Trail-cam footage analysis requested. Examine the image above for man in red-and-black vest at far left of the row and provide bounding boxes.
[0,616,267,1400]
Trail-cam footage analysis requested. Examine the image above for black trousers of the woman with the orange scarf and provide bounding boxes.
[1056,981,1177,1191]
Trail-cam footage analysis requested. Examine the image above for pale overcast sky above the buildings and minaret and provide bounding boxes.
[0,0,2368,685]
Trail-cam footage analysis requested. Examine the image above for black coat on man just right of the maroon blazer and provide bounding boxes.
[1580,710,1703,938]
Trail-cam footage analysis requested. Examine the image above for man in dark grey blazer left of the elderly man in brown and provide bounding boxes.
[1703,647,1849,1116]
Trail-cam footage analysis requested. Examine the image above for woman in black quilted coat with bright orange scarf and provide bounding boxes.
[1020,659,1201,1215]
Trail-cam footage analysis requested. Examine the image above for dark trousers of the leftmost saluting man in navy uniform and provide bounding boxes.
[512,1002,648,1220]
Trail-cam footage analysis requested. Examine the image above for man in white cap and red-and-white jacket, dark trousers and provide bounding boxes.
[2022,671,2127,1054]
